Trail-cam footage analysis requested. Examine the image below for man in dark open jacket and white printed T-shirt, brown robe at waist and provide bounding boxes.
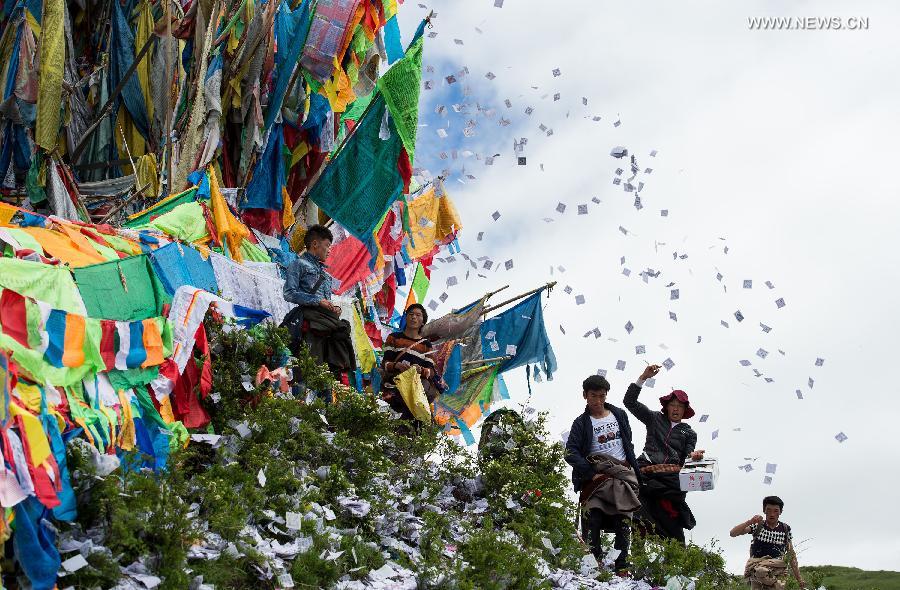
[566,375,644,572]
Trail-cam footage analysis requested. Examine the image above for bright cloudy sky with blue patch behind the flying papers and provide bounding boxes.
[400,0,900,572]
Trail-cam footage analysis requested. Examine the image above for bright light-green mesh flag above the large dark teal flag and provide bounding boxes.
[378,37,423,163]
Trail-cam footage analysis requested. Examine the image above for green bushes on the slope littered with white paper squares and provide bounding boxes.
[49,322,740,590]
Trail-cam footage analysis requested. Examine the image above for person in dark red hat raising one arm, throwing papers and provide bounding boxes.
[625,365,703,543]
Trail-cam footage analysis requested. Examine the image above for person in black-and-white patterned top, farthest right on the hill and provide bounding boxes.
[731,496,806,590]
